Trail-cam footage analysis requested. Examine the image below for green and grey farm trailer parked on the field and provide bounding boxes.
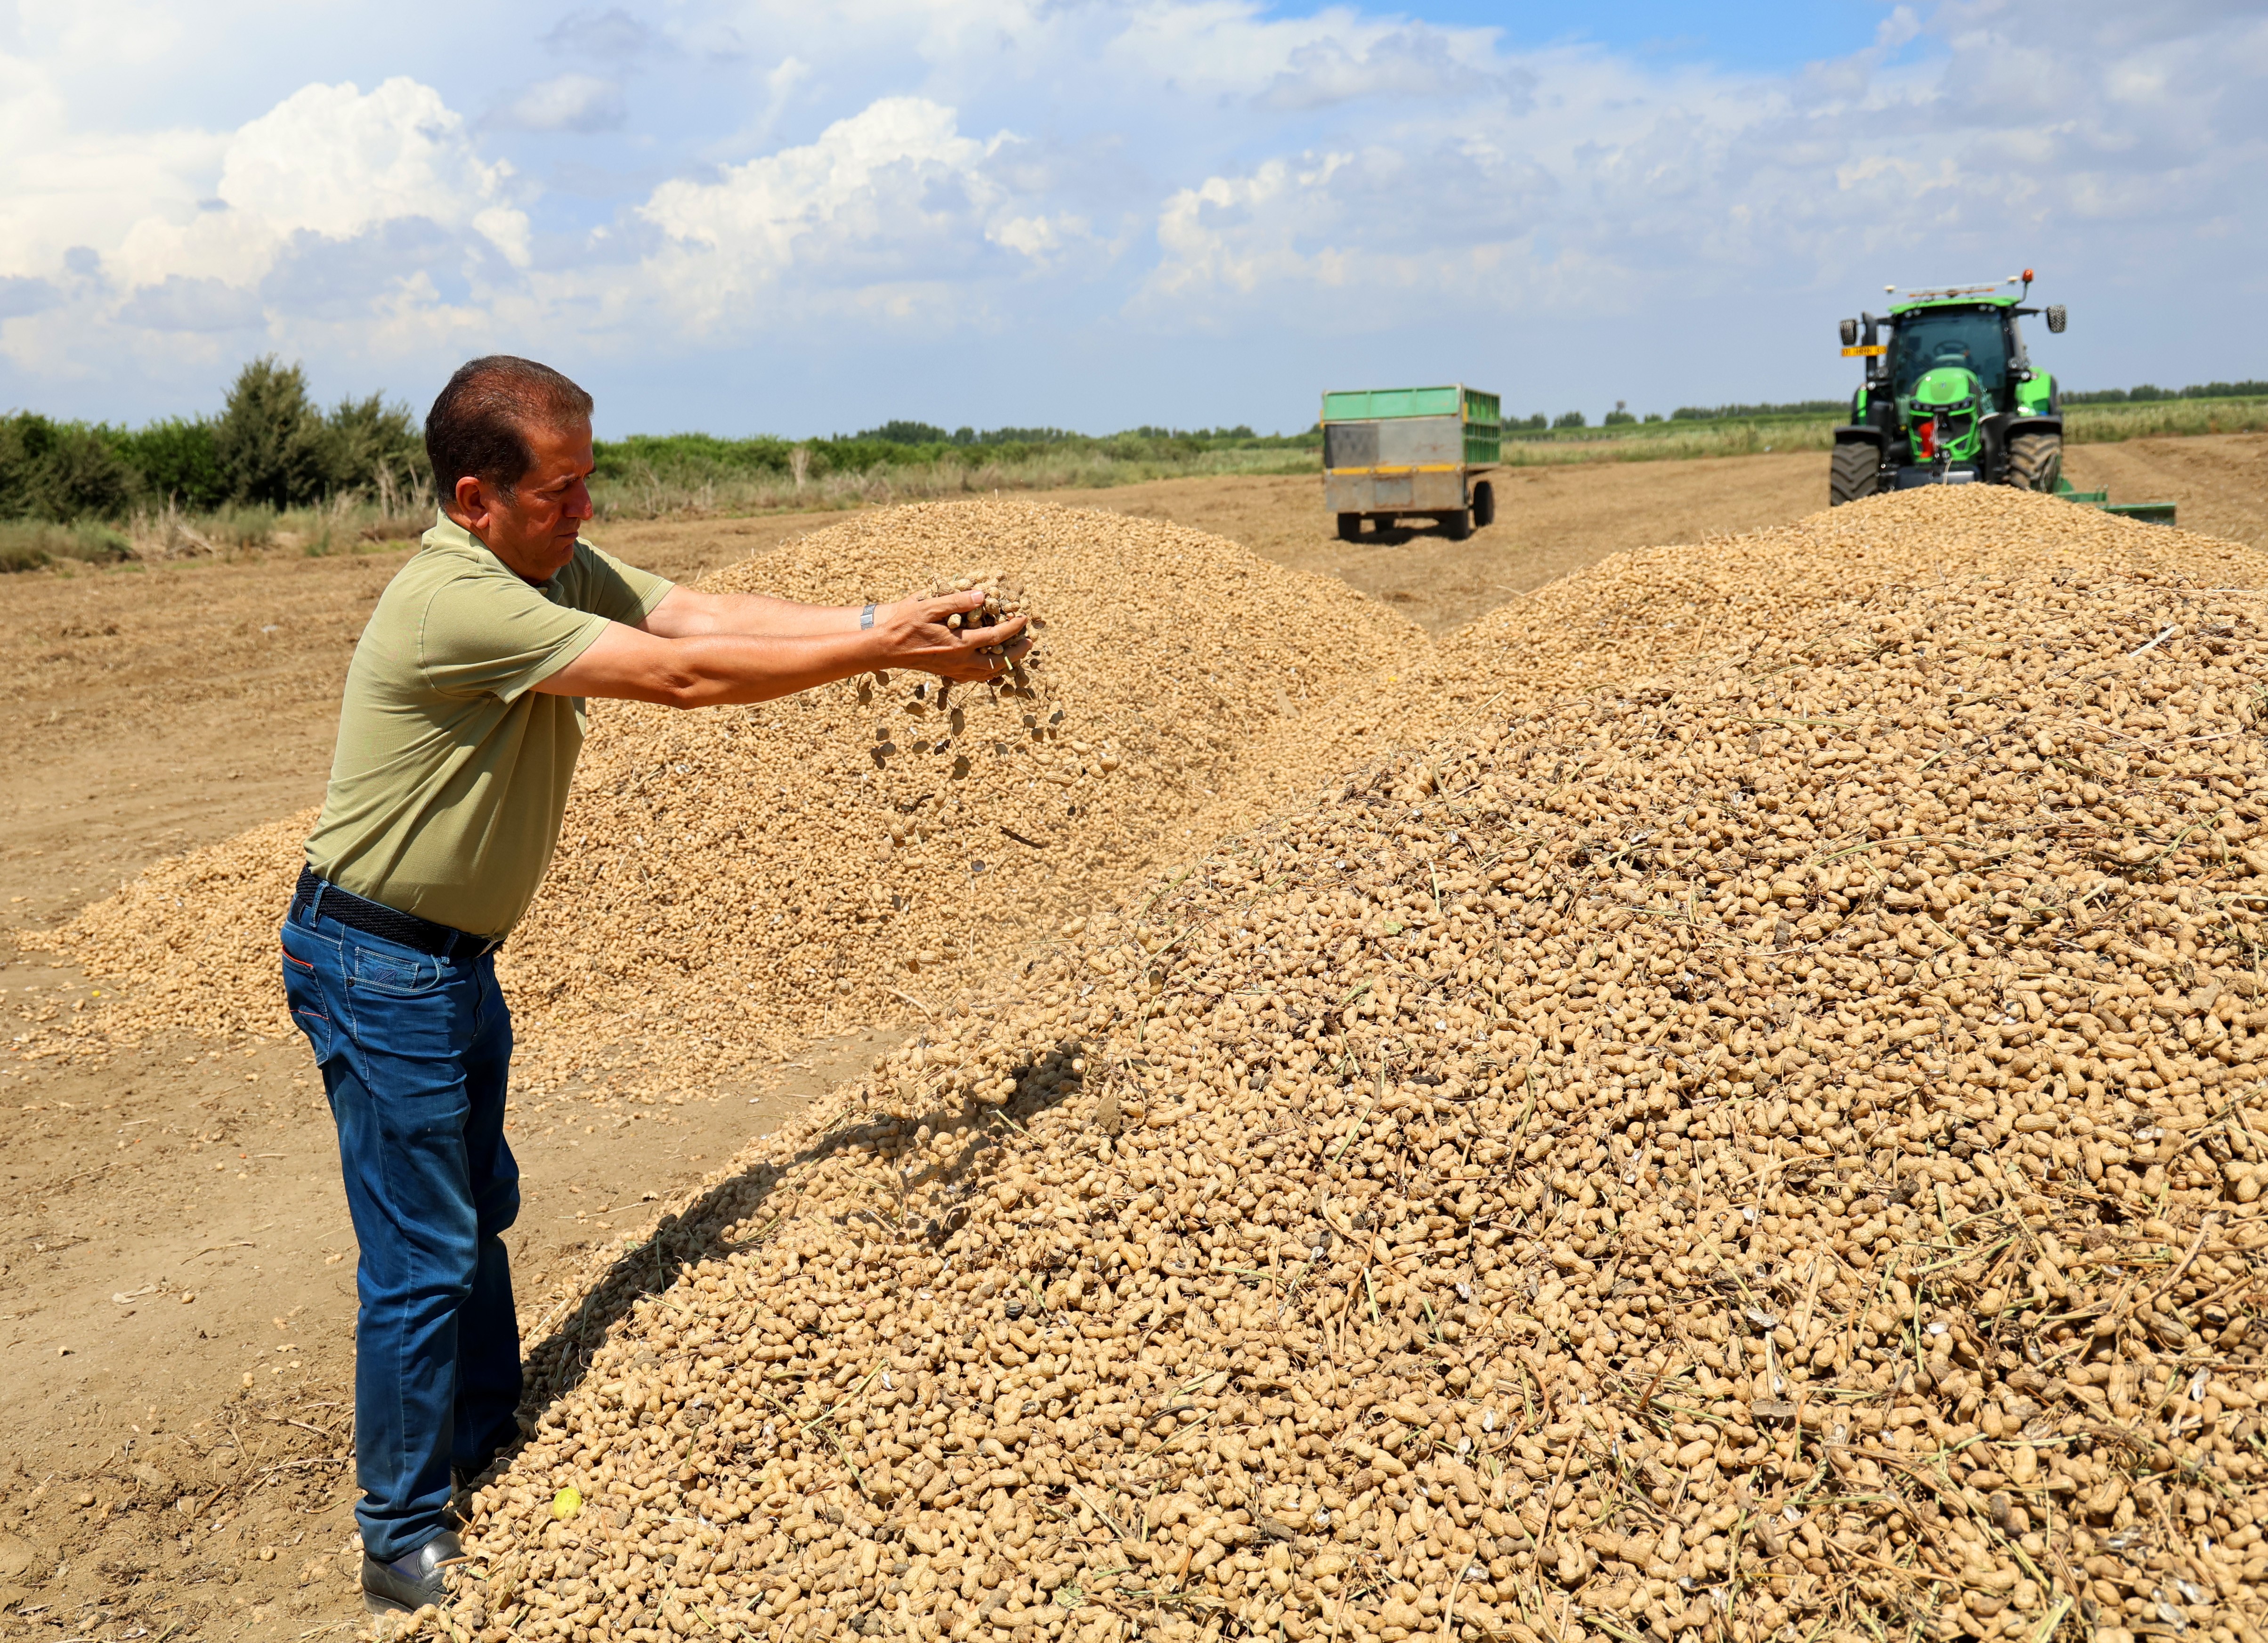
[1322,383,1504,542]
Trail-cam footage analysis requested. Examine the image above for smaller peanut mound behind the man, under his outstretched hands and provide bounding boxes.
[27,502,1422,1098]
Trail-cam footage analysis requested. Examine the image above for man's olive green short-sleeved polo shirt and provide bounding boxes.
[306,517,673,937]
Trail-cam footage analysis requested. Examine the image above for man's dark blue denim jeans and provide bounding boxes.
[284,901,519,1563]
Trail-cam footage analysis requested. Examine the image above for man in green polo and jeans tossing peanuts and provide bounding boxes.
[284,356,1023,1611]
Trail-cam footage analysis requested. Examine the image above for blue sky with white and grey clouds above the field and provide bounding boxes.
[0,0,2268,436]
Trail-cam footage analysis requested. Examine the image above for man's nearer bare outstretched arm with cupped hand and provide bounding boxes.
[535,592,1023,708]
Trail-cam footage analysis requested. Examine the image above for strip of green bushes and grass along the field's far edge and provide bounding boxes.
[0,358,2268,572]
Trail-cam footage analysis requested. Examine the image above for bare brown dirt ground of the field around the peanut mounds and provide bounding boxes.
[0,436,2268,1638]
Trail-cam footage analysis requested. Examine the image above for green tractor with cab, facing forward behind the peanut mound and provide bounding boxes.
[1828,268,2064,506]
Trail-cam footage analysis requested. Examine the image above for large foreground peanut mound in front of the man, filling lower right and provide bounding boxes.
[447,549,2268,1643]
